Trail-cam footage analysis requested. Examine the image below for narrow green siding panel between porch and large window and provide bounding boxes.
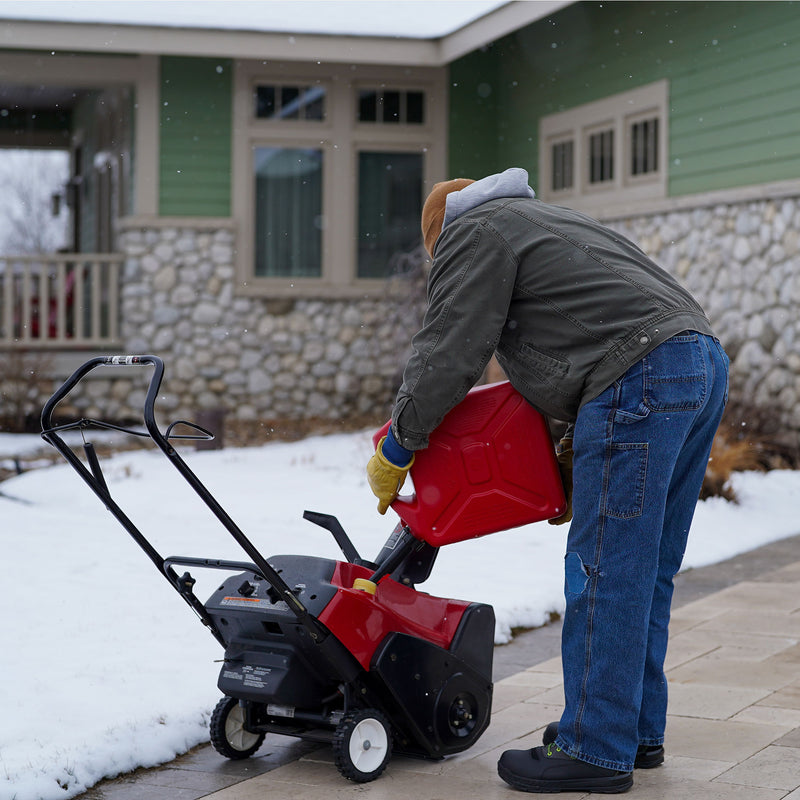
[159,56,232,217]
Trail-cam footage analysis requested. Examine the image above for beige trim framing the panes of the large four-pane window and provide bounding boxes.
[231,61,447,298]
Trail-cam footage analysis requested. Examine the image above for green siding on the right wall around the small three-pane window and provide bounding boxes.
[450,2,800,196]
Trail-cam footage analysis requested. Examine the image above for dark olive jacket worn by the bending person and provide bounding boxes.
[392,195,712,450]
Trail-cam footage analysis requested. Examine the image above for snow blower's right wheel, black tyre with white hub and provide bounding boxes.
[333,708,392,783]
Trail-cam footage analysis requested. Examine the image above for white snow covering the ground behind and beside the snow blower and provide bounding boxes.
[0,431,800,800]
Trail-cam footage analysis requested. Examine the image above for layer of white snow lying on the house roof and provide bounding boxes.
[0,0,510,39]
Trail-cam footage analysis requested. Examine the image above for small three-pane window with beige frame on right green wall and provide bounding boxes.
[539,81,668,213]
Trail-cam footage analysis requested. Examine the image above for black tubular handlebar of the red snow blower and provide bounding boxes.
[41,355,338,644]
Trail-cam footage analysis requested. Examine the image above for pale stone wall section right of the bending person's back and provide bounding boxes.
[609,197,800,448]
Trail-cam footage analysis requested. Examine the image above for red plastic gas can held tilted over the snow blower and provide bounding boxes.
[373,381,566,547]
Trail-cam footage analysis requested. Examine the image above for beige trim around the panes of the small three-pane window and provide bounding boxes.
[537,80,669,215]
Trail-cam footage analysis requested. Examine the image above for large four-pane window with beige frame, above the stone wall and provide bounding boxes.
[231,59,447,299]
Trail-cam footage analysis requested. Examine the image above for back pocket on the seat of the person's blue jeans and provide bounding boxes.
[642,333,707,411]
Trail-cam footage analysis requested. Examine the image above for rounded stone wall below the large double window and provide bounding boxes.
[56,219,424,432]
